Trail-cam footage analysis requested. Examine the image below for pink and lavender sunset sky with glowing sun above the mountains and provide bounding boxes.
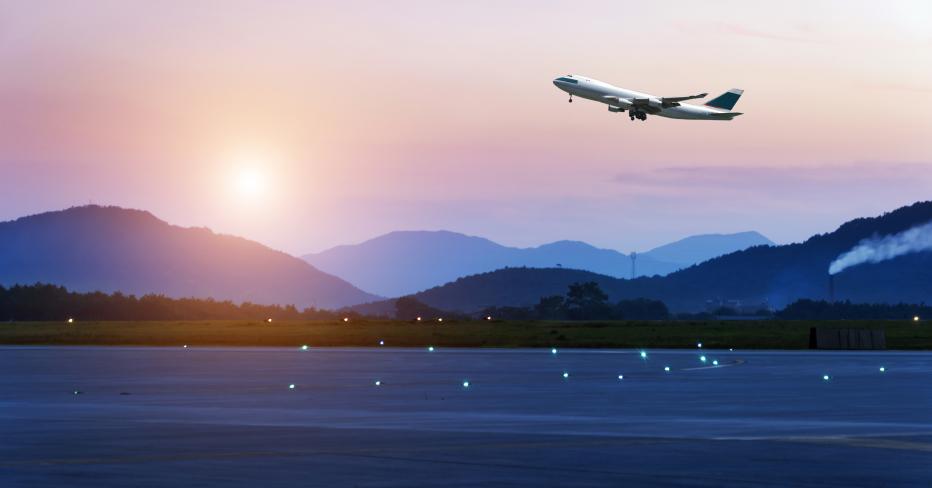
[0,0,932,254]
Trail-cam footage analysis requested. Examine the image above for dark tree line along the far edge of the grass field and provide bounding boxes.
[0,282,932,321]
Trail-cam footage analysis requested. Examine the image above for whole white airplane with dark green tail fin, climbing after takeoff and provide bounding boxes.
[553,75,744,121]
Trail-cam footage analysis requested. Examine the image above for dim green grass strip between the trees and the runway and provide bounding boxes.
[0,320,932,349]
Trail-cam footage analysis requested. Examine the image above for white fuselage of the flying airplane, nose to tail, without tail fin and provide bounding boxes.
[553,75,740,120]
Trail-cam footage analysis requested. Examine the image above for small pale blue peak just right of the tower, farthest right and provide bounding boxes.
[638,231,774,267]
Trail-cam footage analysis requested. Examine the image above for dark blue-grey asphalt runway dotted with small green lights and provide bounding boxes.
[0,347,932,487]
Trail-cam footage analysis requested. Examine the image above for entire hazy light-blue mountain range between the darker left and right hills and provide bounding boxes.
[303,231,771,296]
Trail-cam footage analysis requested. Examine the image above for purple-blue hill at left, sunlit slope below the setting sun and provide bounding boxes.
[0,205,379,308]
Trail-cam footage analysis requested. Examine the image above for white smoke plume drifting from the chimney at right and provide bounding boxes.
[828,222,932,274]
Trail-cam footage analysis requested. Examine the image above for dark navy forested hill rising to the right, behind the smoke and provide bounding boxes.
[370,202,932,312]
